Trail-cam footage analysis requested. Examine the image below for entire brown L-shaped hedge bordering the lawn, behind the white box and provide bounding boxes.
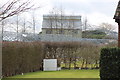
[2,42,100,77]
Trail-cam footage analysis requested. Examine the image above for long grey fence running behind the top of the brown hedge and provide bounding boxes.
[0,31,117,44]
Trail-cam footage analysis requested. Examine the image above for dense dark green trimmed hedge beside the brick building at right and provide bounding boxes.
[100,48,120,80]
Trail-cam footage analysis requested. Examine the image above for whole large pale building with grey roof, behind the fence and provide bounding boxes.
[42,15,82,38]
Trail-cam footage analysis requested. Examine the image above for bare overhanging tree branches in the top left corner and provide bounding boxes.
[0,0,34,22]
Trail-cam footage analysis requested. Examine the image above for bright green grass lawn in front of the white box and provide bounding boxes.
[7,70,99,78]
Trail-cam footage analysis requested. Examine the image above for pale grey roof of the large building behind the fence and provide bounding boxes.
[42,15,82,29]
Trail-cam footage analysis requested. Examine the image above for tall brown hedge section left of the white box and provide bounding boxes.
[2,42,43,76]
